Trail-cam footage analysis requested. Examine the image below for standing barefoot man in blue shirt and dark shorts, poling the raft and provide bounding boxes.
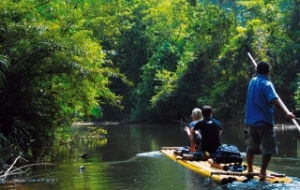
[245,62,295,178]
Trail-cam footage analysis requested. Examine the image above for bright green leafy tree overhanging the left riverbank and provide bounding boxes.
[0,0,127,157]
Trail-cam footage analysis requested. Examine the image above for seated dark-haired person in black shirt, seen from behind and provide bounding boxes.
[190,106,222,154]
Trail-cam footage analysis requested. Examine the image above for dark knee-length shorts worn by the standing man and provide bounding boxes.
[247,124,278,155]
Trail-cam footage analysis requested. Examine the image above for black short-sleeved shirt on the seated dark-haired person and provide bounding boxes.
[194,119,222,153]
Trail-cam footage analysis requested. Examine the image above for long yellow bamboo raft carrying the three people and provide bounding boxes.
[161,147,291,184]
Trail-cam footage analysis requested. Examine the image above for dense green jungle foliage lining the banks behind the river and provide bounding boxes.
[0,0,300,155]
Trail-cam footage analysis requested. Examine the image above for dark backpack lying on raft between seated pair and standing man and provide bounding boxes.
[212,144,243,164]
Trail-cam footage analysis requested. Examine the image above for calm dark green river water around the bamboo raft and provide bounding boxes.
[0,125,300,190]
